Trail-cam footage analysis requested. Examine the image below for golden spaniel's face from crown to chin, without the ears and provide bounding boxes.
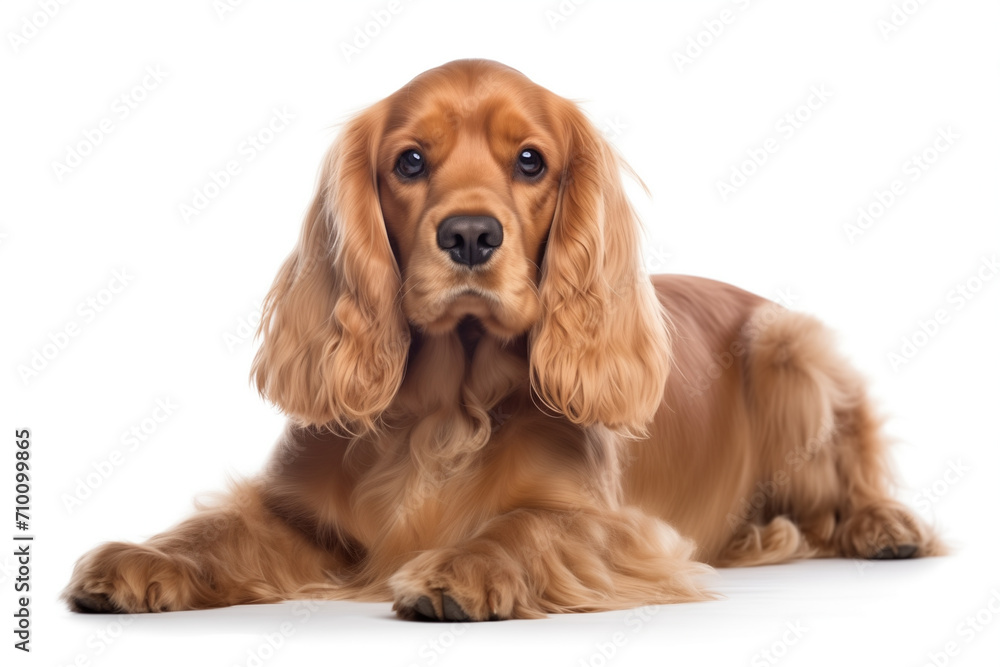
[377,64,566,337]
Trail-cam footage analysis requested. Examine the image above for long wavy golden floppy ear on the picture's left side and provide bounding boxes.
[252,106,409,433]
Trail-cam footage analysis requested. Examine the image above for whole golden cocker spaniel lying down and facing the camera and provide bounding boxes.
[64,60,944,621]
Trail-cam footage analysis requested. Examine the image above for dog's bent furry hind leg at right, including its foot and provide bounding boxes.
[732,306,944,562]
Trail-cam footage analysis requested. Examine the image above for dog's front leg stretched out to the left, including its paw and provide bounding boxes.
[63,484,338,613]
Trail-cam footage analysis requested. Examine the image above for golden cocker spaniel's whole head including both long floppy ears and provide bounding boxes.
[254,60,669,431]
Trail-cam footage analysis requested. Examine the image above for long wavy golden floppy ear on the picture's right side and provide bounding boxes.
[530,100,670,435]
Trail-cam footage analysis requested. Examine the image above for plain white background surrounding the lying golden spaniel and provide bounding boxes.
[0,0,1000,667]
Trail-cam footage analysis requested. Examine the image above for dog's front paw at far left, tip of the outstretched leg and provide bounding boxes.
[62,542,200,614]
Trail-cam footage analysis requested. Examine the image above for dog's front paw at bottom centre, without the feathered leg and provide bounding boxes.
[389,548,545,621]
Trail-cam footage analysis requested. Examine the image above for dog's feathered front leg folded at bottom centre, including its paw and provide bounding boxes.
[389,508,710,621]
